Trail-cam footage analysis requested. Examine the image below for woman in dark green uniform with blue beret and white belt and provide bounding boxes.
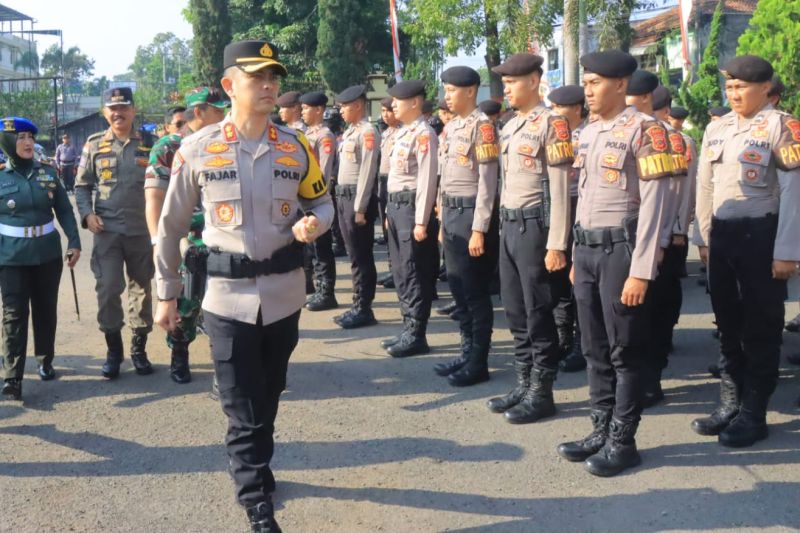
[0,117,81,400]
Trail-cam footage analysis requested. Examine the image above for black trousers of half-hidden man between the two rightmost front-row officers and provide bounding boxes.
[647,245,686,370]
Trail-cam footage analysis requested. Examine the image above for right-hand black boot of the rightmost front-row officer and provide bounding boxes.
[718,379,777,448]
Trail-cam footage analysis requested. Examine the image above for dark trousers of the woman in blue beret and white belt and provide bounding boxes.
[0,258,64,379]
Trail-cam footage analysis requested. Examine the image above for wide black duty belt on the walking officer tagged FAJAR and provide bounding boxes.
[206,241,303,279]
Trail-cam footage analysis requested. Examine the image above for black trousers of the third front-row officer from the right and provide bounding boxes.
[500,219,560,370]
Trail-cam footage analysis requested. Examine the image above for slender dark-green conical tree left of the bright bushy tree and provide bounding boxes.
[678,0,723,132]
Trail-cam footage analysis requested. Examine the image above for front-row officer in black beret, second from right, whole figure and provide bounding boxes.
[558,50,672,476]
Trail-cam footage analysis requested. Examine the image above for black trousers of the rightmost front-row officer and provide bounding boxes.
[708,215,788,393]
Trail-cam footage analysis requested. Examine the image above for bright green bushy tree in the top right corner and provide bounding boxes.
[737,0,800,116]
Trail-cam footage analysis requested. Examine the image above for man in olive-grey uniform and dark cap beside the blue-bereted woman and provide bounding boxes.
[75,87,154,379]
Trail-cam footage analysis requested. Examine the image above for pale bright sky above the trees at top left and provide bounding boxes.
[0,0,192,78]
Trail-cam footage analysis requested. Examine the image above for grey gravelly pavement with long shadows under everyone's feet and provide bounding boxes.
[0,217,800,533]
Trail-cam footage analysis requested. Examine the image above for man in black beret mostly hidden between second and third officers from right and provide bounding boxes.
[547,85,586,372]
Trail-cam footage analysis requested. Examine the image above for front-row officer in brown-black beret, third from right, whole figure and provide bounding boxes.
[488,54,573,424]
